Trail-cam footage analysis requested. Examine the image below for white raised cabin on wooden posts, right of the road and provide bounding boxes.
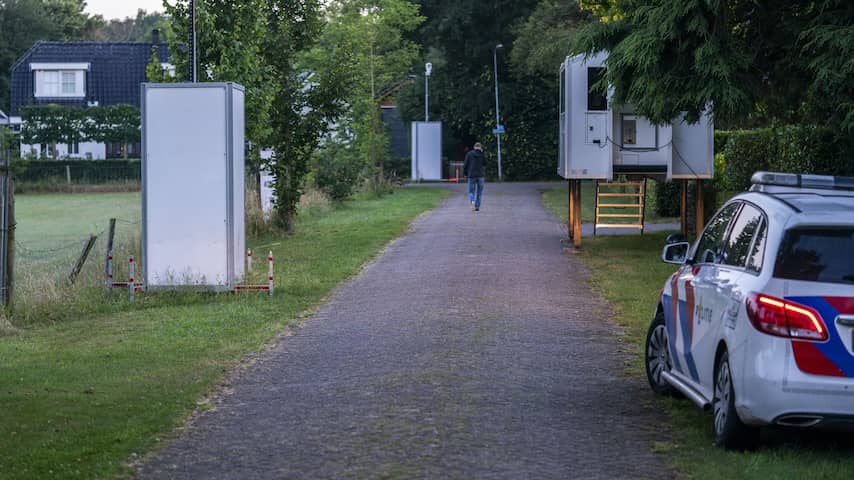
[558,52,714,180]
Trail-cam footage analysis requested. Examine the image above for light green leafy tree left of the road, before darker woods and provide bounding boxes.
[304,0,424,188]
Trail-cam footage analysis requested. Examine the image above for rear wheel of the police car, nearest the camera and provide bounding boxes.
[712,352,759,449]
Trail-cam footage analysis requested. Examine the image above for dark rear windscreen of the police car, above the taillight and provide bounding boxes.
[774,227,854,284]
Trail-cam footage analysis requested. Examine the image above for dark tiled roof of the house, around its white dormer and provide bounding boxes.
[10,41,170,115]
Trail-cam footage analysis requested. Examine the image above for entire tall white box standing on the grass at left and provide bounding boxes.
[142,83,246,291]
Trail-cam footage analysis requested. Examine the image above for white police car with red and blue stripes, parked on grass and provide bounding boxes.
[645,172,854,448]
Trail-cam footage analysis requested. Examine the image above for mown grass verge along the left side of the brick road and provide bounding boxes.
[0,188,448,478]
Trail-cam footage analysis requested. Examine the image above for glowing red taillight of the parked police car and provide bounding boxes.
[747,293,827,342]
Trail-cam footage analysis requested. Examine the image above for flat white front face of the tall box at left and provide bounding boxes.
[143,85,229,287]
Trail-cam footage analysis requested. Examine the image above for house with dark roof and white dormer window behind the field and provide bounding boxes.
[10,39,174,159]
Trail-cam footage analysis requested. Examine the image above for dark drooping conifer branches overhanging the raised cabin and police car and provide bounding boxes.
[573,0,854,128]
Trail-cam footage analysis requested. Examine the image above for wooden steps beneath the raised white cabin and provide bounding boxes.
[593,180,646,235]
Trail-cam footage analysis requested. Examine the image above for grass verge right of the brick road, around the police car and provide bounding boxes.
[543,193,854,480]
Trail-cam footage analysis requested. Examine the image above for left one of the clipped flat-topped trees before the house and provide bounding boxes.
[21,104,86,160]
